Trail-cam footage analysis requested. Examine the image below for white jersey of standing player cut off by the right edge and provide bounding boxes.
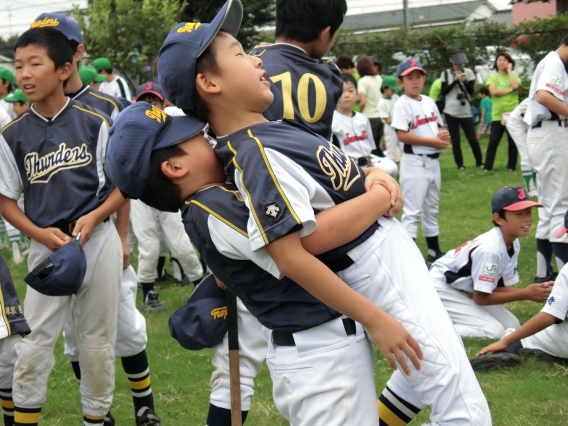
[525,52,568,126]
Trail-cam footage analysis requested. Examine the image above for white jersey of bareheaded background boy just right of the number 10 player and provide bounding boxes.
[331,111,375,158]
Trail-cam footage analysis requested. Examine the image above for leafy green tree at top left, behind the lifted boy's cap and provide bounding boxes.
[74,0,185,87]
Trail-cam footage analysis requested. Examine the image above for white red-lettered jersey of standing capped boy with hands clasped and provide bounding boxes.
[391,95,444,154]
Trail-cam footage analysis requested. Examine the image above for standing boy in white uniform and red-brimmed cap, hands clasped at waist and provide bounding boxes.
[391,59,450,264]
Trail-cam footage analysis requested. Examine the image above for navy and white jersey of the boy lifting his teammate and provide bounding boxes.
[182,185,340,333]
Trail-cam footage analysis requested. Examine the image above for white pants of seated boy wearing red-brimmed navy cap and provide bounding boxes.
[430,268,521,339]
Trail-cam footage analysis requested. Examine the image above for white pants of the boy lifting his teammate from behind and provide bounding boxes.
[263,318,379,426]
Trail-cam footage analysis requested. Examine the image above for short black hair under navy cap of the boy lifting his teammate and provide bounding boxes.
[140,144,187,213]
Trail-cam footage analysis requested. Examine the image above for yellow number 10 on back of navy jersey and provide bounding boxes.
[270,71,327,123]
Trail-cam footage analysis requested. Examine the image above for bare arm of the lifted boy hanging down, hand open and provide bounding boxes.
[266,232,422,375]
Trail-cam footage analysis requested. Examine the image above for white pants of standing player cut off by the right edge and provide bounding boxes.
[527,120,568,243]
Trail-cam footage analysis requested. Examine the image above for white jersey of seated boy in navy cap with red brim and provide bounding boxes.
[432,226,521,293]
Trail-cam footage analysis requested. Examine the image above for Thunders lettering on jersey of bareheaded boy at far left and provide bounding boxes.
[24,142,93,184]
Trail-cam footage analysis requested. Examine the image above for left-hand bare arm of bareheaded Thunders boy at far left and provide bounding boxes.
[0,194,71,251]
